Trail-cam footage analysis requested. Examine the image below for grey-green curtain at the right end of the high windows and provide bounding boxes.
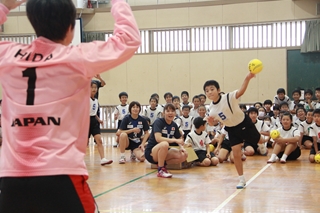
[301,20,320,53]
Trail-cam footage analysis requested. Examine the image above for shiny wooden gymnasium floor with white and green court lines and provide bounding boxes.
[85,133,320,213]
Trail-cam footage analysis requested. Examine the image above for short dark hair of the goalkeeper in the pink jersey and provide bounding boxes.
[26,0,77,41]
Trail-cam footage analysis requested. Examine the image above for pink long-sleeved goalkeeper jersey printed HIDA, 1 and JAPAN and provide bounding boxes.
[0,0,140,177]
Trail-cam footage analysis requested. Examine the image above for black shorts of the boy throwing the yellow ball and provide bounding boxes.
[225,115,261,146]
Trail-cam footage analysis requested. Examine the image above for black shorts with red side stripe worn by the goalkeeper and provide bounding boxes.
[0,175,97,213]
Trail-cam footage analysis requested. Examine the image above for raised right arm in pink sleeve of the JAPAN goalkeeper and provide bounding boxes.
[78,0,141,77]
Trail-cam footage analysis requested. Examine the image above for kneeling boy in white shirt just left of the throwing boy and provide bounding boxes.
[185,117,219,166]
